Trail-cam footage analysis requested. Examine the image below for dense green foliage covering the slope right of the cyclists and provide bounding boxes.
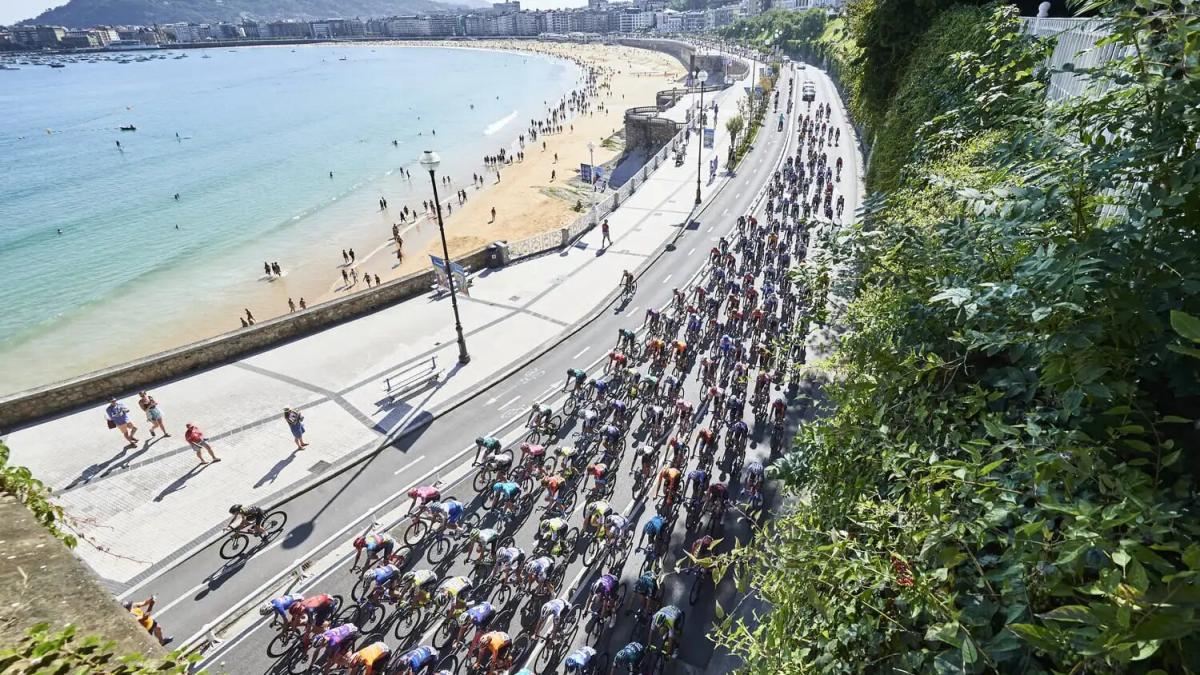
[714,0,1200,674]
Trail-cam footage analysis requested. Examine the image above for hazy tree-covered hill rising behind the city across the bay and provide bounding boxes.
[23,0,487,28]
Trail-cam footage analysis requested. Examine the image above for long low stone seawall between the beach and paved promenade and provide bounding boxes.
[0,243,487,430]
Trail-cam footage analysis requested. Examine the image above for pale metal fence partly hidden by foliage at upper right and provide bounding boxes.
[1021,17,1124,101]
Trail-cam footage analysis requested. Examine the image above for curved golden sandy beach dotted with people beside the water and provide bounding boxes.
[5,40,683,395]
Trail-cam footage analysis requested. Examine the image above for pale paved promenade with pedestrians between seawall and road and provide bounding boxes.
[6,78,743,589]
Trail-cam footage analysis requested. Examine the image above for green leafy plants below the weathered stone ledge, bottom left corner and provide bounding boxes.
[0,623,190,675]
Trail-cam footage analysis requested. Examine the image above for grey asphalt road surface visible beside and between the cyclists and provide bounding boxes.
[154,56,852,673]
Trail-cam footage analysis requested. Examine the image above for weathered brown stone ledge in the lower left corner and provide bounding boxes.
[0,495,170,657]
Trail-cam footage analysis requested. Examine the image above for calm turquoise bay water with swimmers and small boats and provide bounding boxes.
[0,46,580,393]
